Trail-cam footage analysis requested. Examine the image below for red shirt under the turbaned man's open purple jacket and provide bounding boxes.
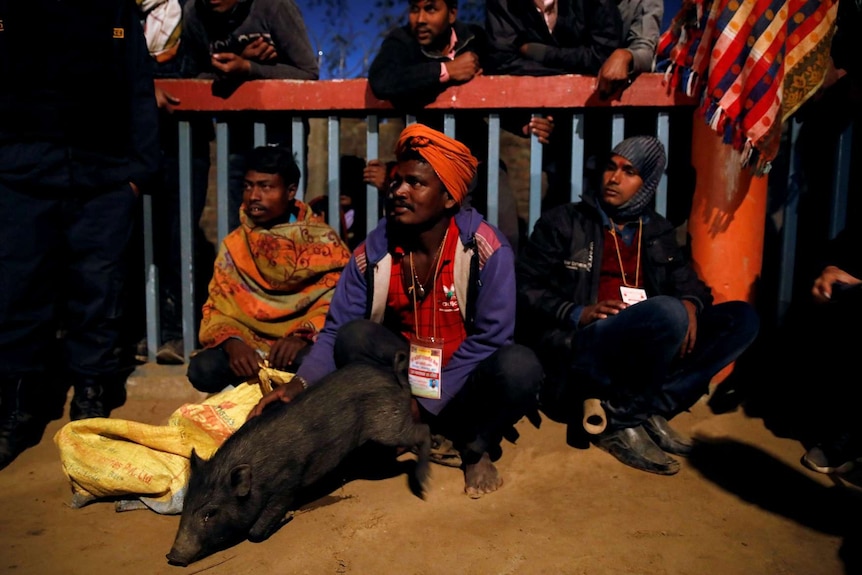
[383,219,467,366]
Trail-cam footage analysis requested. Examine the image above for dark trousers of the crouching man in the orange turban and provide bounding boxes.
[335,319,543,463]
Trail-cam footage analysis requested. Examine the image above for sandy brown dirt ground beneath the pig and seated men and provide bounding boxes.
[0,365,862,575]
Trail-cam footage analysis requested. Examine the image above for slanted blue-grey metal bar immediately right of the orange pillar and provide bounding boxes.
[776,122,803,324]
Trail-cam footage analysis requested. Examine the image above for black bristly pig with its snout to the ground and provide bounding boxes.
[167,354,431,566]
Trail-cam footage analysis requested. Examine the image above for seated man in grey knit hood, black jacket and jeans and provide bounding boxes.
[516,136,760,475]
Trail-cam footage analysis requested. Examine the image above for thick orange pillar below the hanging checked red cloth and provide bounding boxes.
[688,116,768,383]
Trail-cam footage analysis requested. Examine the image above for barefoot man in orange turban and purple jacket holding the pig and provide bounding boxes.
[249,124,543,498]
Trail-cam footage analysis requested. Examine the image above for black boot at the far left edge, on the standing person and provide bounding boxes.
[0,377,45,469]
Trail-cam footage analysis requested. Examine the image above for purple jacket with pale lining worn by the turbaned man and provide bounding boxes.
[297,208,515,414]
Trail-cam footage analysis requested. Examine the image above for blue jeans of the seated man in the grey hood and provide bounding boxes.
[568,296,760,430]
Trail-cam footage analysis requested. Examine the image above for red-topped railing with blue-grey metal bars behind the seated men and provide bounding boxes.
[144,74,852,361]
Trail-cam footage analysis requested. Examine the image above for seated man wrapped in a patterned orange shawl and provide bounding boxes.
[188,146,350,392]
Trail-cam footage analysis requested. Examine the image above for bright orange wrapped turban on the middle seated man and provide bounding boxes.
[395,124,479,204]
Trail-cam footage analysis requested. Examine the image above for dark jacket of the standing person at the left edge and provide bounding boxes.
[0,0,159,189]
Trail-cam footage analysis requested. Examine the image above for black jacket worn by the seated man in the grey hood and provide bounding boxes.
[516,197,712,353]
